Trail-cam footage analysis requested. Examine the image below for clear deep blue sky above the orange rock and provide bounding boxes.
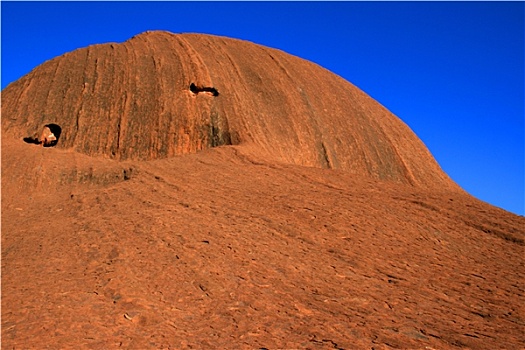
[1,1,525,215]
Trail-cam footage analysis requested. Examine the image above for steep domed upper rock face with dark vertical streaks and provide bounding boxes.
[2,32,456,187]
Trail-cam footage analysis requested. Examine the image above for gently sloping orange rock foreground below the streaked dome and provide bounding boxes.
[2,135,525,349]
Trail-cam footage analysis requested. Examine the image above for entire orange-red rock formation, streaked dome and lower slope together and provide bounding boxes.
[1,32,525,349]
